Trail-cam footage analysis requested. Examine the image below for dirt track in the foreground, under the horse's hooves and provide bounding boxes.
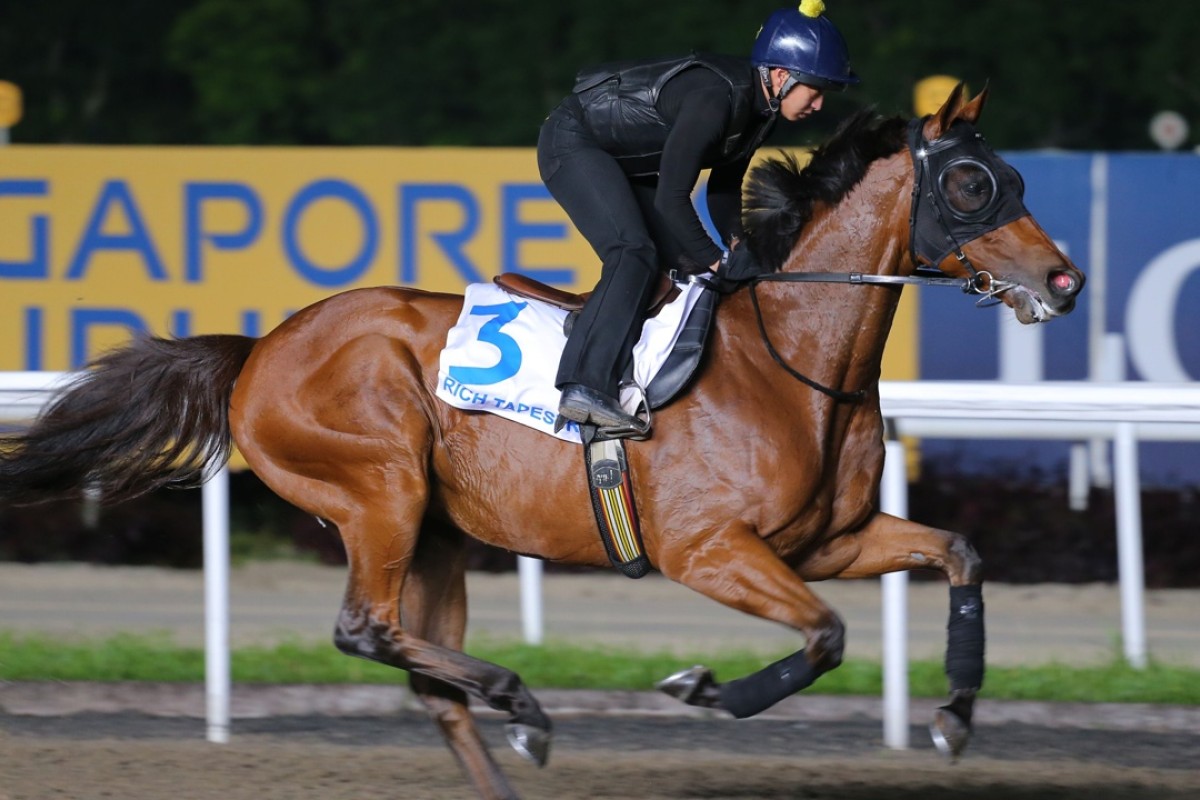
[0,712,1200,800]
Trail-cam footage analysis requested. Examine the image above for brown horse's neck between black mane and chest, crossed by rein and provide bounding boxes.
[724,154,912,391]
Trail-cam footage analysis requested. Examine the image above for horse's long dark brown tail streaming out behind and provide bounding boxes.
[0,335,257,505]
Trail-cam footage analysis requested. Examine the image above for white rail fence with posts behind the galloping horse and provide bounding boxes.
[0,372,1200,747]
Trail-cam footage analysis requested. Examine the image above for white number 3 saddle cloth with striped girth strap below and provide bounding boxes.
[437,279,716,578]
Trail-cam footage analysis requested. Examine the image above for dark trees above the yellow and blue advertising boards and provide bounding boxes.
[0,0,1200,150]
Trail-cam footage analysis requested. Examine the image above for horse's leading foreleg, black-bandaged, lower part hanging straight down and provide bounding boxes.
[799,513,984,758]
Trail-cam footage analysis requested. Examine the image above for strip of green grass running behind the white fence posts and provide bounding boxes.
[0,633,1200,705]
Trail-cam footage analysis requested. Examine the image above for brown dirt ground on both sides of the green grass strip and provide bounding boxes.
[0,565,1200,800]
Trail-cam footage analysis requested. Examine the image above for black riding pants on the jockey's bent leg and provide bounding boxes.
[538,103,659,397]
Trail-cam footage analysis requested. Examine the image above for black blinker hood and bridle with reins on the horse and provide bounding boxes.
[749,118,1030,402]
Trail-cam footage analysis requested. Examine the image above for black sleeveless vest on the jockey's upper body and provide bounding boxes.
[572,53,774,174]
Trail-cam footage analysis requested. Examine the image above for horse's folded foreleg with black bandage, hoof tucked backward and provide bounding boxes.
[659,529,845,718]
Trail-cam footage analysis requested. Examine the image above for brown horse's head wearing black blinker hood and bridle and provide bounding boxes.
[908,83,1084,324]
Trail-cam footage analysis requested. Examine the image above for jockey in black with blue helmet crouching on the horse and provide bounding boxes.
[538,0,858,429]
